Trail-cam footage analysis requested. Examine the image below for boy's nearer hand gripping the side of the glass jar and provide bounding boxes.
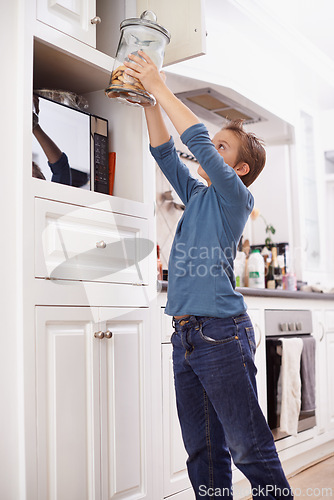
[124,50,165,95]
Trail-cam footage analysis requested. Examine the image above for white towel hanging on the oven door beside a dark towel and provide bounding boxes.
[279,338,303,436]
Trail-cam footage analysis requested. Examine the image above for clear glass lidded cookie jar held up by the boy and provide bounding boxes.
[105,10,170,107]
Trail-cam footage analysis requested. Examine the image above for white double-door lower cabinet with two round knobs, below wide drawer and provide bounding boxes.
[36,307,152,500]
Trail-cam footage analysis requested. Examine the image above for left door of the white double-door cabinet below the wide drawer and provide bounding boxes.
[36,306,100,500]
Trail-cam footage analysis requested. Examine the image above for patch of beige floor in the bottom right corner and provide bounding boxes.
[289,455,334,500]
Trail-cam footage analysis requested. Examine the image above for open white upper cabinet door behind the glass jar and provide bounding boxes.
[137,0,206,66]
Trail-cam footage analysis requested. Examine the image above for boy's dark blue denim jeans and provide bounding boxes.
[171,313,293,500]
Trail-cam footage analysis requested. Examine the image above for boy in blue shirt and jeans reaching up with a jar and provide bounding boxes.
[125,51,293,499]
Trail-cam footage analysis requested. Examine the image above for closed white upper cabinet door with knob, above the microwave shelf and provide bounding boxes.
[37,0,96,47]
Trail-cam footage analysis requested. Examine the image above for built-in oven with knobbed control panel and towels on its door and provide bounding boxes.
[265,309,316,440]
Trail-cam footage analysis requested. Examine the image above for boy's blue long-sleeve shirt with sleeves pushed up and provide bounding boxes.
[150,123,254,318]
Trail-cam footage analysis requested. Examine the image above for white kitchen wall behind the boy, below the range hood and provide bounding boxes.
[156,108,293,269]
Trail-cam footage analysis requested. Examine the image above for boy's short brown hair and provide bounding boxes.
[223,120,266,187]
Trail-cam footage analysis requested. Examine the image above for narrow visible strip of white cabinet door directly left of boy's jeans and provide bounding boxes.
[161,344,193,498]
